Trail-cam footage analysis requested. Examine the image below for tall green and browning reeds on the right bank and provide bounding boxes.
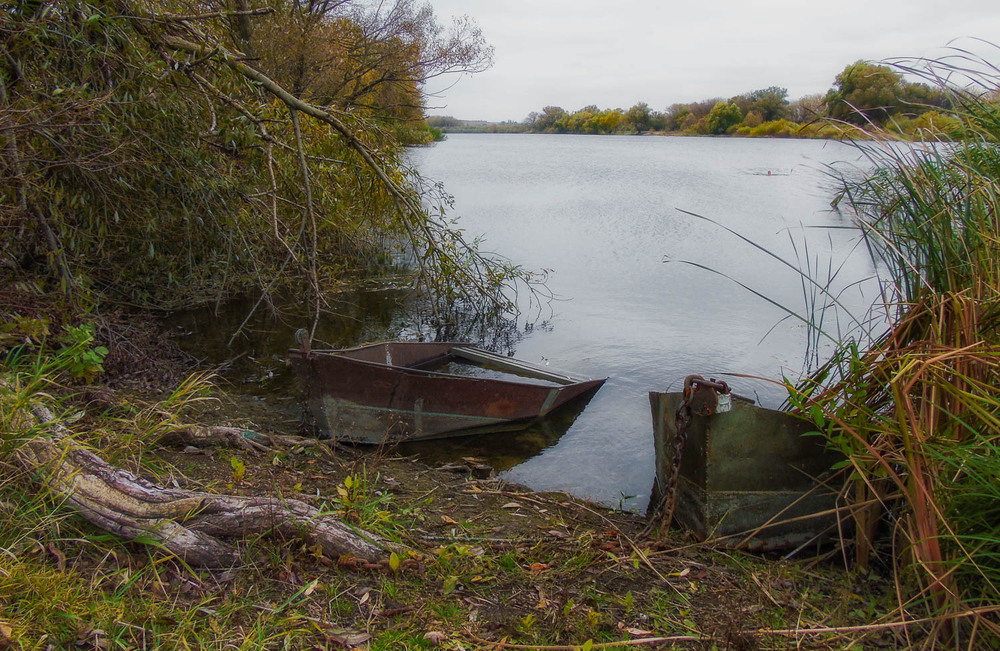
[790,54,1000,648]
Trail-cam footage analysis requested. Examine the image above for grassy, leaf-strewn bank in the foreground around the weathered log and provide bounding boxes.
[0,314,908,650]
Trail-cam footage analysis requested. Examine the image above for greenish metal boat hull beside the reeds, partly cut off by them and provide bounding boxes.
[649,392,843,551]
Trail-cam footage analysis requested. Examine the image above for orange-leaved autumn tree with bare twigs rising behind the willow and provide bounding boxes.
[226,0,493,135]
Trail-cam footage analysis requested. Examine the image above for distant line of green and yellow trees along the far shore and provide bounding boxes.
[432,61,957,138]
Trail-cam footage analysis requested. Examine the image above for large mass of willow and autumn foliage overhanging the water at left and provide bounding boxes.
[0,0,530,326]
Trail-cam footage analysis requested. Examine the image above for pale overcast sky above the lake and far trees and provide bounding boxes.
[427,0,1000,121]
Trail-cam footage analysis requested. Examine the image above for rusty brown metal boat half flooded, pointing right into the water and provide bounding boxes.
[289,342,605,445]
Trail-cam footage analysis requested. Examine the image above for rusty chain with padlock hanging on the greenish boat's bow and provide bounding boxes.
[643,375,732,534]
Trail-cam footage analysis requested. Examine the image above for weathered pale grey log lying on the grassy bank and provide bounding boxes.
[15,405,388,567]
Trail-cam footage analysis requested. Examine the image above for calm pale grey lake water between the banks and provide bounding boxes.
[412,134,874,510]
